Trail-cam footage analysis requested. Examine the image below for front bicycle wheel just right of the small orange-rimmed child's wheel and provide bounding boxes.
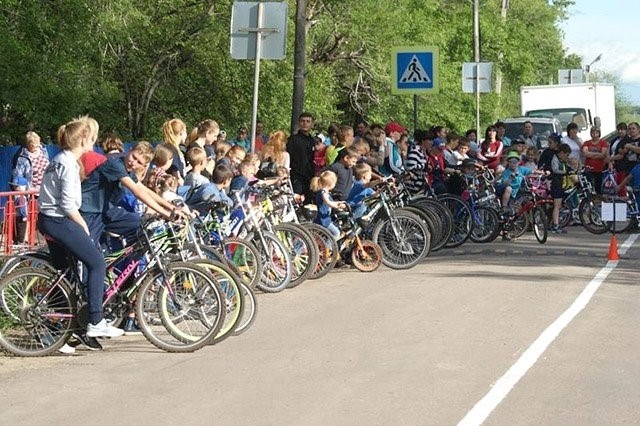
[371,209,431,269]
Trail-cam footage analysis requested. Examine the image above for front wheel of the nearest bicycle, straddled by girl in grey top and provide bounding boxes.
[136,262,225,352]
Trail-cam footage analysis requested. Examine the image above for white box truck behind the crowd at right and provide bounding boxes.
[520,83,616,141]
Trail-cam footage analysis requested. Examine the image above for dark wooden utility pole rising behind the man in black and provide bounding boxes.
[291,0,307,134]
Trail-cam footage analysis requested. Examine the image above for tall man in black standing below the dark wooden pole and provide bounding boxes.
[287,112,315,203]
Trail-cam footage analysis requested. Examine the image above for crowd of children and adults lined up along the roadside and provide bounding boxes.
[5,113,640,349]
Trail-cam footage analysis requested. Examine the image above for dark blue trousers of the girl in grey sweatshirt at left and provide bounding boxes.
[38,213,106,324]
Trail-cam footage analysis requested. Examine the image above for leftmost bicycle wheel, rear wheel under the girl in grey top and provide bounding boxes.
[0,268,77,357]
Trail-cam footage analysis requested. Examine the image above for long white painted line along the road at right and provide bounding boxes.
[458,234,639,426]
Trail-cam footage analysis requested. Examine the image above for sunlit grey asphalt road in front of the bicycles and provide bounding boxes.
[0,227,640,425]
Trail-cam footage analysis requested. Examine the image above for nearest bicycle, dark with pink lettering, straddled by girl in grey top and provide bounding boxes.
[0,216,225,356]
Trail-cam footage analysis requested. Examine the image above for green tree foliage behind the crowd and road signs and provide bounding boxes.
[0,0,580,145]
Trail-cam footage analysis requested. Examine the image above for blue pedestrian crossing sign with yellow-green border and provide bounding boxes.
[391,46,439,94]
